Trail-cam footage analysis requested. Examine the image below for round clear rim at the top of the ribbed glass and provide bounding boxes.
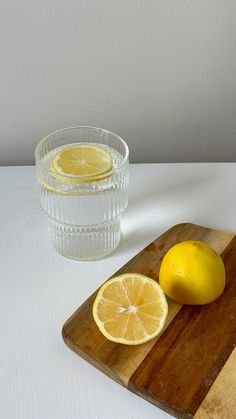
[35,125,129,183]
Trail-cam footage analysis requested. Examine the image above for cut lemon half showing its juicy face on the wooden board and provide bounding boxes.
[93,273,168,345]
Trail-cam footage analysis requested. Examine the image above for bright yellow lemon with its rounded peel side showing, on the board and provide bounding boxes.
[159,240,225,304]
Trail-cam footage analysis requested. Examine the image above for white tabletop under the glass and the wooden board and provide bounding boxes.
[0,163,236,419]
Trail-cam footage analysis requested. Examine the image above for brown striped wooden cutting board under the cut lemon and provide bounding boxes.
[62,223,236,419]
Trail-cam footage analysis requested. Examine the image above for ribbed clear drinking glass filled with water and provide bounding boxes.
[35,127,129,260]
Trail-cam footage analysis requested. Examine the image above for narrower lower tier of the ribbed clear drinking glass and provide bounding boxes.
[48,217,121,261]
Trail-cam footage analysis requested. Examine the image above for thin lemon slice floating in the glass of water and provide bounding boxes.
[51,144,112,182]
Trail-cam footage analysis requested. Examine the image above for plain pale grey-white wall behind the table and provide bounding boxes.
[0,0,236,164]
